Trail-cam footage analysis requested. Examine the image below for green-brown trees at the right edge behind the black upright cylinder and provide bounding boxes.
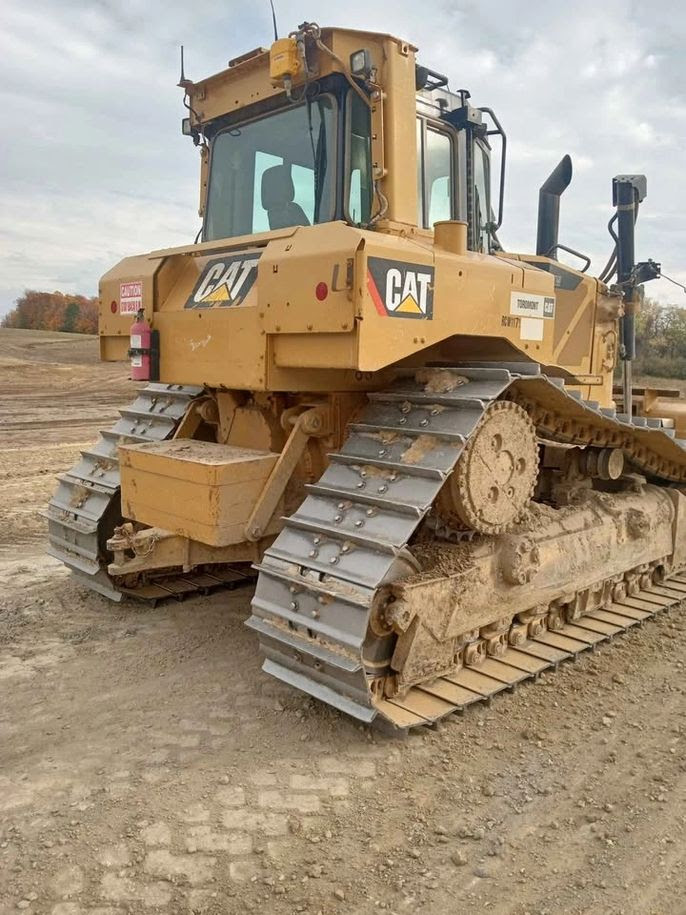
[634,299,686,378]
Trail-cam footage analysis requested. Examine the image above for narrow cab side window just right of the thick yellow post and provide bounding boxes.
[417,118,455,229]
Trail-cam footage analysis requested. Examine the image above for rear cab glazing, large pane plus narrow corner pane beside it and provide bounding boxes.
[203,74,372,241]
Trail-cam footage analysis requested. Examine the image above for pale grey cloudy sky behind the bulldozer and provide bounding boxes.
[0,0,686,313]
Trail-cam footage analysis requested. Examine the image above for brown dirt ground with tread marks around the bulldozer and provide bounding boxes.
[0,331,686,915]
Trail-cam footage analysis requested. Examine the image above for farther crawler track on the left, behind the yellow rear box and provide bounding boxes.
[43,383,252,604]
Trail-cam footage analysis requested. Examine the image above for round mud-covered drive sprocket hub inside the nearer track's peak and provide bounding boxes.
[437,400,538,535]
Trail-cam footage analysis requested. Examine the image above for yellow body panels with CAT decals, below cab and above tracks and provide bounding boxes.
[100,222,619,405]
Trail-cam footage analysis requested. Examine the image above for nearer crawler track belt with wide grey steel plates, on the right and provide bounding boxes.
[247,363,686,729]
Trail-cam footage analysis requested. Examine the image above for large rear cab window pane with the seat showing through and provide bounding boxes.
[204,95,335,241]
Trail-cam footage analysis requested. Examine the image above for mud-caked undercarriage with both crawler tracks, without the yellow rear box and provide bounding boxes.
[48,364,686,729]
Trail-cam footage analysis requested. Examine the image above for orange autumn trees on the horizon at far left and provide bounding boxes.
[0,289,98,334]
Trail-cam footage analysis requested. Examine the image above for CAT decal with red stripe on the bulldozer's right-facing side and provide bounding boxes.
[367,257,434,319]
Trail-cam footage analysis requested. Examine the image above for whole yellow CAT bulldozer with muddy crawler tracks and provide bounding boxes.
[47,23,686,731]
